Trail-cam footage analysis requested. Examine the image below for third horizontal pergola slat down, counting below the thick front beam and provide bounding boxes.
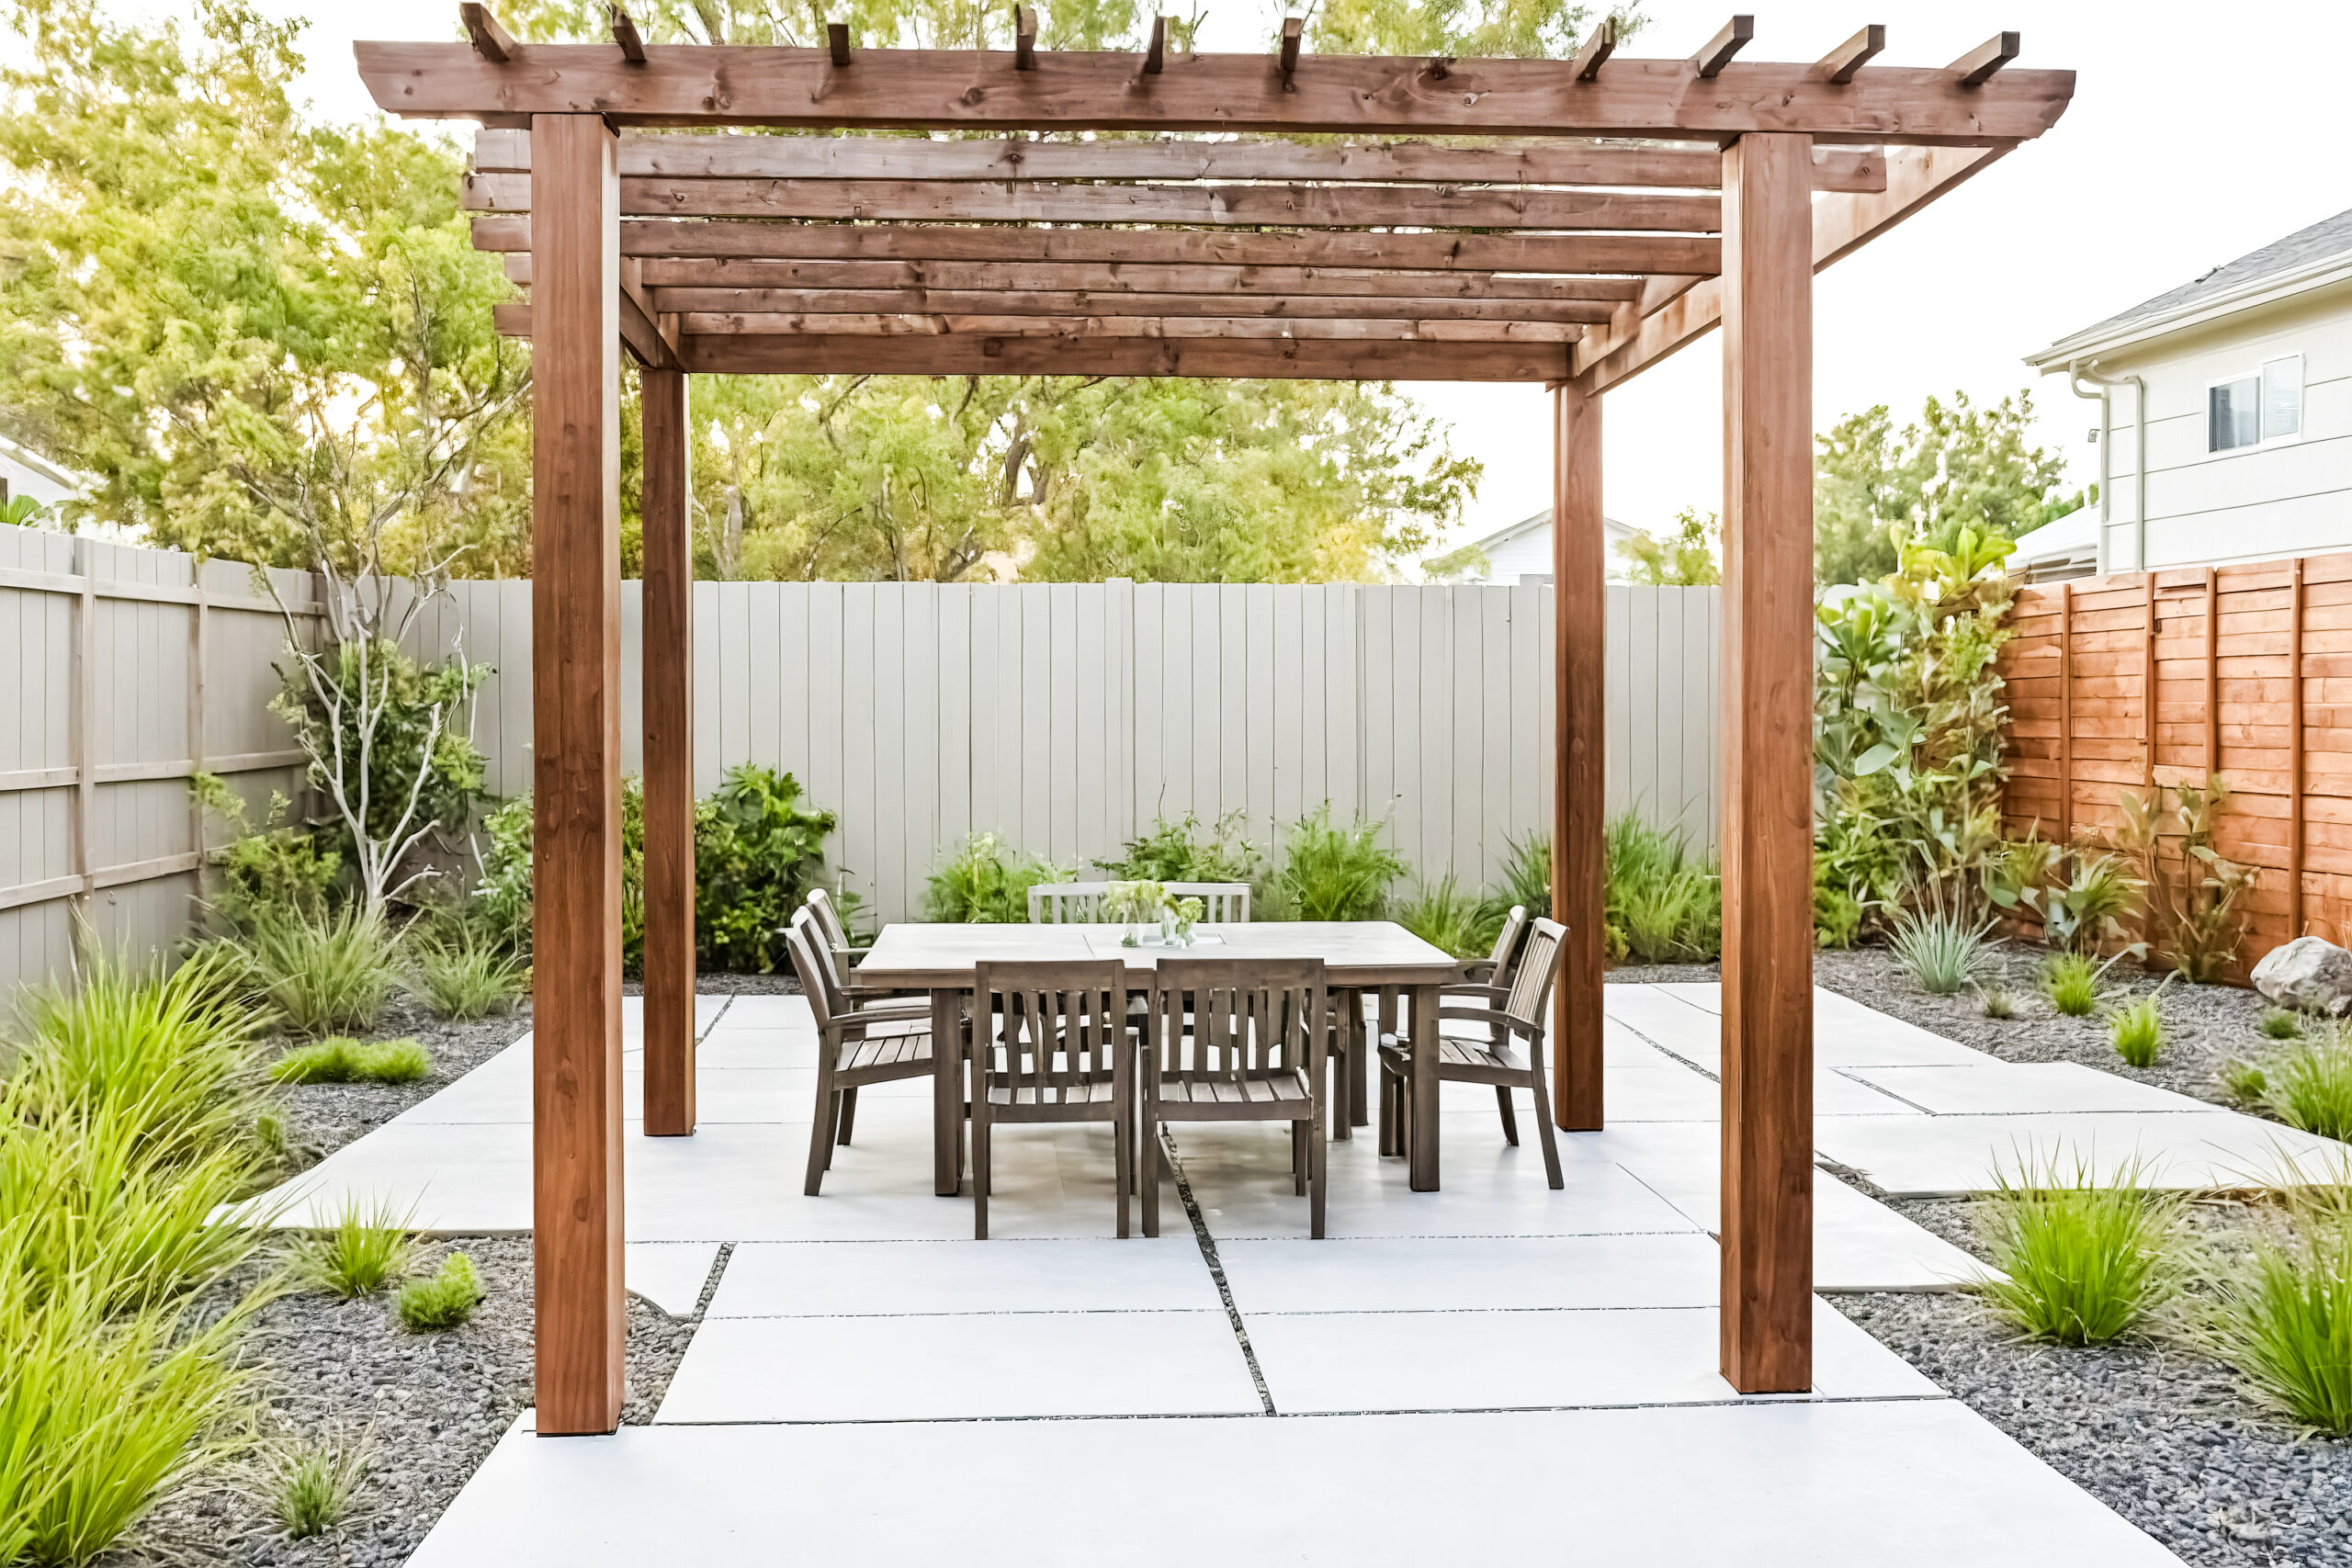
[473,219,1724,277]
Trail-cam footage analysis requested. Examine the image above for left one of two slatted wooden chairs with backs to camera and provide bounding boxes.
[971,959,1136,1241]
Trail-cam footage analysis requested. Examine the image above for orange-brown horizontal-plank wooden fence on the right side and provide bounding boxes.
[1996,555,2352,966]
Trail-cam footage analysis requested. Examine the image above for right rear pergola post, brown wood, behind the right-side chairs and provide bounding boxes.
[1538,381,1609,1134]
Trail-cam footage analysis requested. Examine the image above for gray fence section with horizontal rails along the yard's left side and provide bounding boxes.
[0,526,315,992]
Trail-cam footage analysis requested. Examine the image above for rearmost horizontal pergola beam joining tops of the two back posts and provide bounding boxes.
[677,336,1569,381]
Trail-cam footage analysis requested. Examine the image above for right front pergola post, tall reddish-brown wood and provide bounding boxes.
[1722,134,1814,1394]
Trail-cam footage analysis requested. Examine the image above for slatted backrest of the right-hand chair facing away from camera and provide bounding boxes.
[1148,957,1331,1081]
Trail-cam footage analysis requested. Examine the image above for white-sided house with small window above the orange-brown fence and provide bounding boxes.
[2011,211,2352,581]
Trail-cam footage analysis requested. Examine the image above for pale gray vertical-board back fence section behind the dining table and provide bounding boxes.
[414,581,1719,919]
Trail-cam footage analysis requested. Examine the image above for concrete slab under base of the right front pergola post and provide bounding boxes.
[1242,1298,1943,1416]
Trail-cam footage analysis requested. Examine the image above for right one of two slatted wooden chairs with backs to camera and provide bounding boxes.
[1136,957,1331,1241]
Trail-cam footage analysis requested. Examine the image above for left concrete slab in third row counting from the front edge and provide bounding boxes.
[708,1227,1226,1319]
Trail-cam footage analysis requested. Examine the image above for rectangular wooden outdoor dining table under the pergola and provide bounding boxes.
[852,919,1461,1197]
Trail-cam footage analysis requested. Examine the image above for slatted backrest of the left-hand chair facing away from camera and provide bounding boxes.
[971,959,1126,1100]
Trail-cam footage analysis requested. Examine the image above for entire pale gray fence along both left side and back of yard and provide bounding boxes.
[0,529,1719,992]
